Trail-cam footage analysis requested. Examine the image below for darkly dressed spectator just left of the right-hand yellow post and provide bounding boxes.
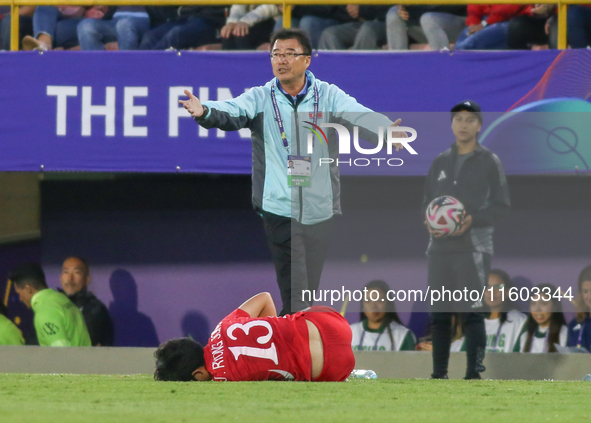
[507,4,556,50]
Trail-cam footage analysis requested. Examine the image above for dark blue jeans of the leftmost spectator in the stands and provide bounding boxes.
[33,6,83,48]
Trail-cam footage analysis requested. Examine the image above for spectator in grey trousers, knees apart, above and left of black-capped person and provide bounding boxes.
[386,5,466,50]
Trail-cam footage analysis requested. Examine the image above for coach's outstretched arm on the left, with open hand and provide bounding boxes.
[179,87,261,131]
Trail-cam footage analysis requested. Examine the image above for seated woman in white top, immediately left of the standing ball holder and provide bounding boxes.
[351,280,417,351]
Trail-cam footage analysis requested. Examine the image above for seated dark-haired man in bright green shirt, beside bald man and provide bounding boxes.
[8,264,91,347]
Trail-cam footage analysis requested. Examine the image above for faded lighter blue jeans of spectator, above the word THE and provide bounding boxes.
[78,15,150,50]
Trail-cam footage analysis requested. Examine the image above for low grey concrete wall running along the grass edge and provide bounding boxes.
[0,346,591,380]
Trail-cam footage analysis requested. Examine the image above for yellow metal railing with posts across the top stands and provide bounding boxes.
[5,0,589,51]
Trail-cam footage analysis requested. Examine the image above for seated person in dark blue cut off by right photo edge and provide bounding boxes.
[566,266,591,352]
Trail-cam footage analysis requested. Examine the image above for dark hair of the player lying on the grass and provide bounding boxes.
[154,338,205,382]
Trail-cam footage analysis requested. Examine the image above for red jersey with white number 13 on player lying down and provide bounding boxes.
[204,309,312,381]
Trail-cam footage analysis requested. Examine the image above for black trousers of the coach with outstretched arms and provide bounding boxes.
[263,212,333,316]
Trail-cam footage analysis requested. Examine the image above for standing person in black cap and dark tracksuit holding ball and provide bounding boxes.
[422,101,510,379]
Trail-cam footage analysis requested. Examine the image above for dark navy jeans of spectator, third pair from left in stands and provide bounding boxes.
[140,16,218,50]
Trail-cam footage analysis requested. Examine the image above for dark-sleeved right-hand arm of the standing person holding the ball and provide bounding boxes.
[472,154,511,228]
